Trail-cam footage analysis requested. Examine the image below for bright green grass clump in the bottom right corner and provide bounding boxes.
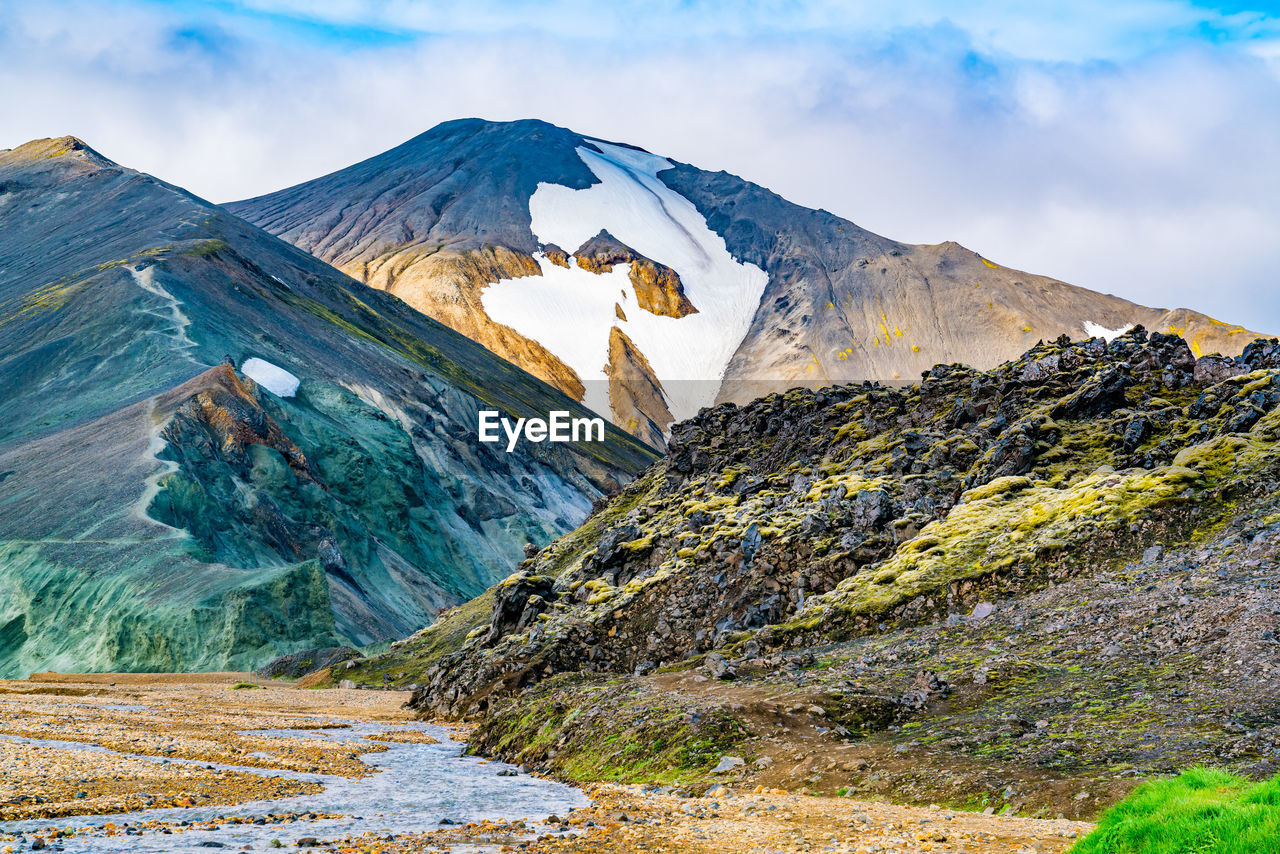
[1071,768,1280,854]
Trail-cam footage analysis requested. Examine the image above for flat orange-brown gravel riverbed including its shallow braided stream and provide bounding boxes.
[0,673,1089,854]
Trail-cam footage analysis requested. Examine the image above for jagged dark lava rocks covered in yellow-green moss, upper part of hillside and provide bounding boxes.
[413,328,1280,713]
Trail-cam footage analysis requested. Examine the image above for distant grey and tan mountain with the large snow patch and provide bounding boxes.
[229,119,1254,444]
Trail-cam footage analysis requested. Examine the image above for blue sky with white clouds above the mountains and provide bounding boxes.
[0,0,1280,333]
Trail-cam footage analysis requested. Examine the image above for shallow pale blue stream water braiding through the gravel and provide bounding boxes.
[0,721,589,851]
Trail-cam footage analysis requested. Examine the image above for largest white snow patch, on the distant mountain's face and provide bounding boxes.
[481,141,768,420]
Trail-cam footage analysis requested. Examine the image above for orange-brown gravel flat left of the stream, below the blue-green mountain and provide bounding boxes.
[0,673,407,821]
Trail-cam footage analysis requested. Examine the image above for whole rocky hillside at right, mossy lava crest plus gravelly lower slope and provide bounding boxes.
[337,329,1280,816]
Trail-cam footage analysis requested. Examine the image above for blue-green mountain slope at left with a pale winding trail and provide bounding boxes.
[0,137,653,676]
